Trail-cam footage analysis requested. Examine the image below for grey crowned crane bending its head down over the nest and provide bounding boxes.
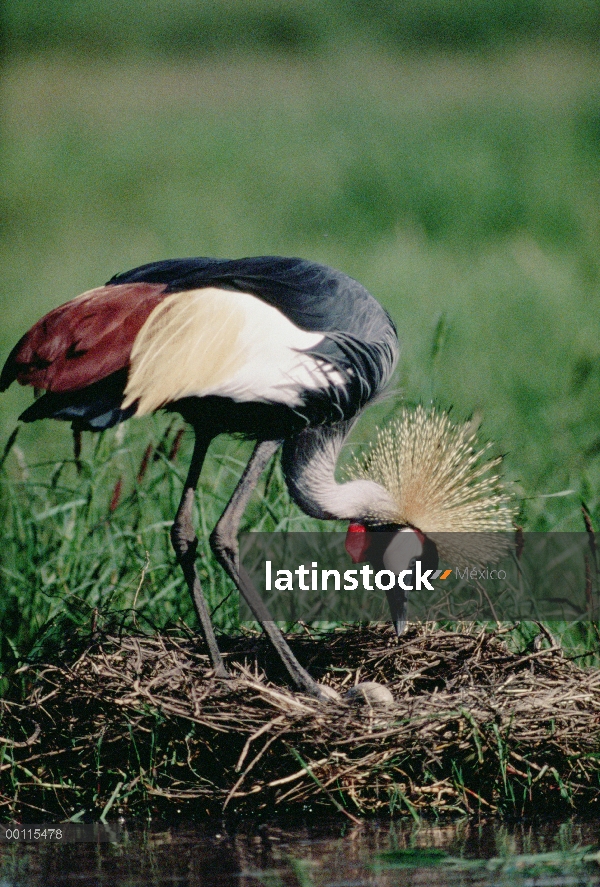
[0,256,511,698]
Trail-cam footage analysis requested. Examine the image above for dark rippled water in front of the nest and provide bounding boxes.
[0,818,600,887]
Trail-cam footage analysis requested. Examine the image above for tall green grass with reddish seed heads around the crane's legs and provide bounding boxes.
[0,419,340,666]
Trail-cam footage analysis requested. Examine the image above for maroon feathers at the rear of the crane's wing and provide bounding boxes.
[0,283,166,392]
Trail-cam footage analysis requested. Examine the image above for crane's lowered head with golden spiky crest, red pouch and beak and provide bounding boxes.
[346,406,515,634]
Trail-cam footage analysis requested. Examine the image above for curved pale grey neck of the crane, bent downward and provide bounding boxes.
[282,421,397,523]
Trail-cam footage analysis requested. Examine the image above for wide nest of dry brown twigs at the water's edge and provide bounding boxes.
[0,626,600,821]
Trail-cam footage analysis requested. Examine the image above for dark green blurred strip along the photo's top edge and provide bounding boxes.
[4,0,600,56]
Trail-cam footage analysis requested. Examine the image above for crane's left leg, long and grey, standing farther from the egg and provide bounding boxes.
[171,432,229,678]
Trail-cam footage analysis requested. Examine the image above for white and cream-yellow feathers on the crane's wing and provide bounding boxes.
[122,287,342,416]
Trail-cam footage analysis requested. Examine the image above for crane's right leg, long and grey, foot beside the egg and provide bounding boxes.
[210,440,331,700]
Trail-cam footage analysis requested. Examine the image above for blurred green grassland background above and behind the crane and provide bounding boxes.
[0,0,600,656]
